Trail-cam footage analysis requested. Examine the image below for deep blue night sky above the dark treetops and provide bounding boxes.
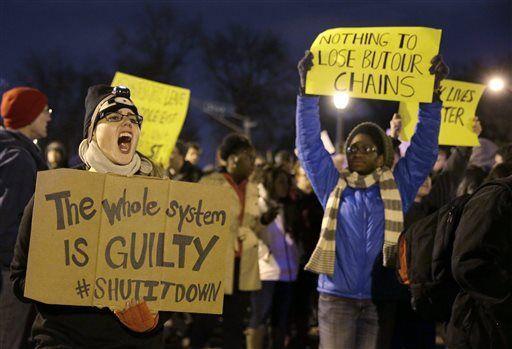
[0,0,512,163]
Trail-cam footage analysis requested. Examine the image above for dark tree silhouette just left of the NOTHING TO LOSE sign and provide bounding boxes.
[201,24,297,149]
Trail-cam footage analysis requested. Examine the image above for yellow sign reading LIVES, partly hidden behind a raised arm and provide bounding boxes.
[398,80,485,147]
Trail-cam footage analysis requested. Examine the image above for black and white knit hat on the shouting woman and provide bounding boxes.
[83,85,138,139]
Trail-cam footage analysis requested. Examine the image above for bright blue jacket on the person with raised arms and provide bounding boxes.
[296,96,441,299]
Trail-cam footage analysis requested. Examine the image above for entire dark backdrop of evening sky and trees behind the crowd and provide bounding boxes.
[0,0,512,164]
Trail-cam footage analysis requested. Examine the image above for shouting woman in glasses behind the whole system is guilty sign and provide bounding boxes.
[11,85,168,348]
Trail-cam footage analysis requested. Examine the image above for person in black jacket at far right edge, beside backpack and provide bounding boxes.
[447,176,512,349]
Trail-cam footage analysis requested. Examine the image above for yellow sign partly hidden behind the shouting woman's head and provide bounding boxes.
[112,72,190,168]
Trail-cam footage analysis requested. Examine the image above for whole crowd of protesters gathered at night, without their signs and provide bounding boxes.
[0,52,512,349]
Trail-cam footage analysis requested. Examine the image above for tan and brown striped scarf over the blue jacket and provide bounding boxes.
[305,167,404,276]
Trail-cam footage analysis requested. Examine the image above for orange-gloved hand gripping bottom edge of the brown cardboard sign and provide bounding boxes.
[114,300,158,333]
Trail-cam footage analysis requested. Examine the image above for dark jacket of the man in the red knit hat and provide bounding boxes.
[0,128,47,268]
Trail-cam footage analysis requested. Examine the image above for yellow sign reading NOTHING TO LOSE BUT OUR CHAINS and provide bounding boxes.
[306,27,441,102]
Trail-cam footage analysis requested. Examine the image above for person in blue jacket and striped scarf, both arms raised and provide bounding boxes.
[296,52,448,349]
